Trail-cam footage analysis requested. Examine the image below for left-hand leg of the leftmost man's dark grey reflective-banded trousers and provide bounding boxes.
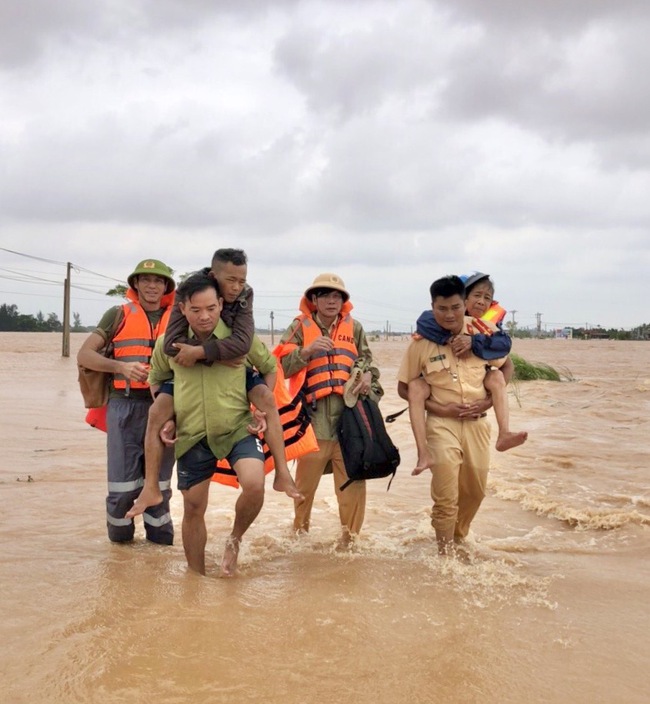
[106,399,150,543]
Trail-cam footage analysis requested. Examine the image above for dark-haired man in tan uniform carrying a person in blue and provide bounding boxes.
[397,276,512,554]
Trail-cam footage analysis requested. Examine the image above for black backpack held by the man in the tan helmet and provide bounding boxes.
[336,398,400,491]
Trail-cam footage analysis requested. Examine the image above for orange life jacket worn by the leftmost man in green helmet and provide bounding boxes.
[113,289,174,389]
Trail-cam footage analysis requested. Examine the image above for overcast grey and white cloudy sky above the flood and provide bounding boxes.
[0,0,650,331]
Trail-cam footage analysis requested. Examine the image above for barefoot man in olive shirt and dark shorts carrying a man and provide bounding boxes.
[129,273,276,576]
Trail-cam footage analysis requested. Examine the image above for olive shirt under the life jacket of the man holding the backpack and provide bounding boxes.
[281,316,384,440]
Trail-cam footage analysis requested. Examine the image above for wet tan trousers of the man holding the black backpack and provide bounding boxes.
[293,440,366,535]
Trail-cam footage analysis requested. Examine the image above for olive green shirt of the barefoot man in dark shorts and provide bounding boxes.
[149,320,277,459]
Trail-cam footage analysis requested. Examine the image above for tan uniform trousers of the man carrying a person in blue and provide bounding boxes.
[427,415,490,539]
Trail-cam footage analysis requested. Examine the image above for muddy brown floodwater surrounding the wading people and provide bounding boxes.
[0,333,650,704]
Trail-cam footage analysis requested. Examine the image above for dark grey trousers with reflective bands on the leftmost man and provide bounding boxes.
[106,398,174,545]
